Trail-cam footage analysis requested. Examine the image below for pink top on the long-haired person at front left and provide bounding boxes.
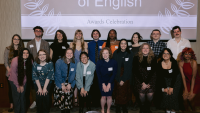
[8,57,26,88]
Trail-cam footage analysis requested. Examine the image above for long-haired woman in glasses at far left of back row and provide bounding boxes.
[4,34,24,112]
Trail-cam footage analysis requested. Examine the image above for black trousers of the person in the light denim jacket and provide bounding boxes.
[78,90,91,108]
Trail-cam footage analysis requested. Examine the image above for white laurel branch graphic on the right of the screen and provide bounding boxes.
[158,0,194,34]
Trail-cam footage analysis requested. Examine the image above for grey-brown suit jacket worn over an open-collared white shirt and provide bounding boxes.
[26,39,50,59]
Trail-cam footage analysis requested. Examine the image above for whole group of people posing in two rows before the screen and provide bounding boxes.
[4,26,200,113]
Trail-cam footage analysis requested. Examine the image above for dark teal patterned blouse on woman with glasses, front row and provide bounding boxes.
[32,62,54,86]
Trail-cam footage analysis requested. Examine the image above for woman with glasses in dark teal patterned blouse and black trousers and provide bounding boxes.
[32,49,54,113]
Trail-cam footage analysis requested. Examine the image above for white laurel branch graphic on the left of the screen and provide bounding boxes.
[24,0,61,35]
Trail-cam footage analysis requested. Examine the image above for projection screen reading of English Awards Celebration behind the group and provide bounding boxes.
[21,0,198,40]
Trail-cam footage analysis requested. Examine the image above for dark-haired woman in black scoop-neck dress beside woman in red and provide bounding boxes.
[157,48,181,113]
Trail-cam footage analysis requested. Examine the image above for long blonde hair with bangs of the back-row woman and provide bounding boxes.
[72,29,85,51]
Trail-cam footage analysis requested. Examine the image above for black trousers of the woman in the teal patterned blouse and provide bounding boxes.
[34,83,51,113]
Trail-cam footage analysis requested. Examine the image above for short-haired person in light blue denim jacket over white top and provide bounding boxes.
[76,52,95,113]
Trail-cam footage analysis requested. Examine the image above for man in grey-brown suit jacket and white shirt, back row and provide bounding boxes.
[26,26,50,109]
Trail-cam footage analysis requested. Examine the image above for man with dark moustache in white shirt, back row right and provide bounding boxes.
[167,26,191,59]
